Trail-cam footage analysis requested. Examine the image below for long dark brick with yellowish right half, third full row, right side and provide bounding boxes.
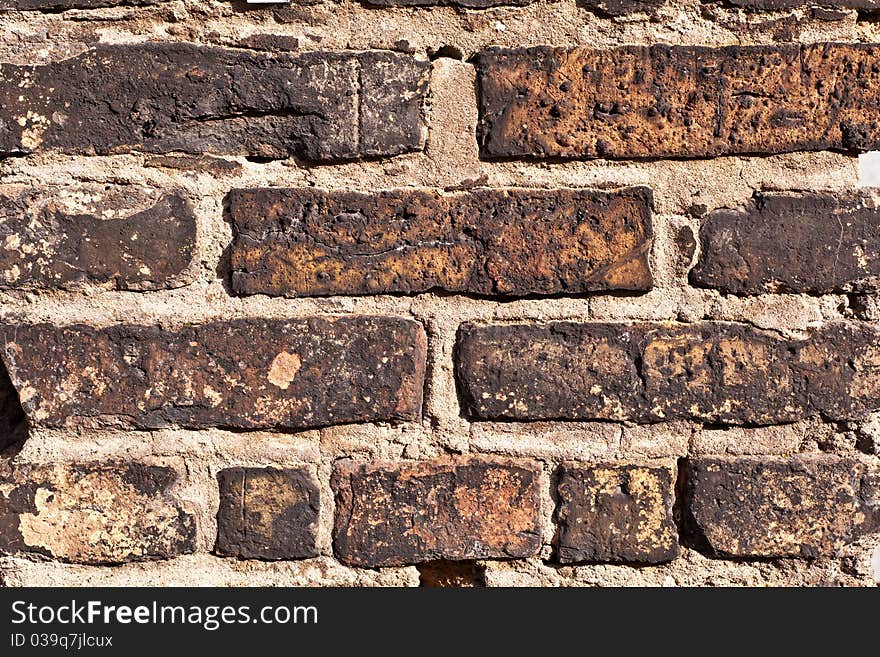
[456,322,880,425]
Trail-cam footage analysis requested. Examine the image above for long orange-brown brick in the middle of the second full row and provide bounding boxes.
[229,187,652,296]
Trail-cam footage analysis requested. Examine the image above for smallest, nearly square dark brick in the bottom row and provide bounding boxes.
[214,468,319,559]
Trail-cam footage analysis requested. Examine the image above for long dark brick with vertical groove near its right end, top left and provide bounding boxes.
[0,43,429,162]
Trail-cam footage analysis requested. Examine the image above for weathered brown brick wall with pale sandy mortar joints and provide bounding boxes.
[0,0,880,586]
